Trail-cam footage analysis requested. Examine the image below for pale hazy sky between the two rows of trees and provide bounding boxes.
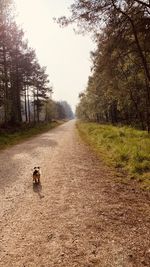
[15,0,94,109]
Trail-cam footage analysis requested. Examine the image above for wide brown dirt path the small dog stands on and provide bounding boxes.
[0,121,150,267]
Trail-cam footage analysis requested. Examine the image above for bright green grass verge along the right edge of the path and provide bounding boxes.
[77,122,150,188]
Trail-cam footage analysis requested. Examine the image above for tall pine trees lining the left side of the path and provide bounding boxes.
[0,0,71,125]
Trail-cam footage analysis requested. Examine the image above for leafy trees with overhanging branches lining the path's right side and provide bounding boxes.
[61,0,150,131]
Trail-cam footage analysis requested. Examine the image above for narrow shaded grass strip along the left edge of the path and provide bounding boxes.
[0,121,62,150]
